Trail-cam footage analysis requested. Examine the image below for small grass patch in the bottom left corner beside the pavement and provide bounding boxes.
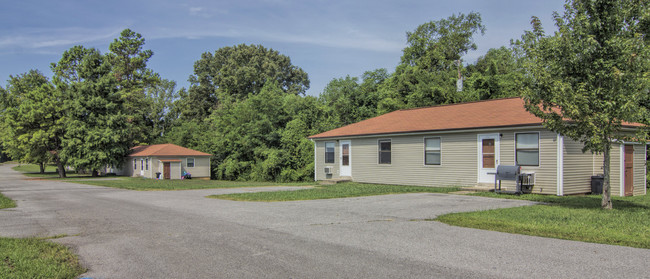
[0,237,86,279]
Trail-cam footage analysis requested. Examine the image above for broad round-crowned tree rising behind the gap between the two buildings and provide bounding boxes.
[185,44,309,119]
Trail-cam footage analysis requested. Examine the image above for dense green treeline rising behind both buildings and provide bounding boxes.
[0,1,644,190]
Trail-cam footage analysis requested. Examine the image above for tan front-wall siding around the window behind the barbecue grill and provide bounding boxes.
[499,129,557,195]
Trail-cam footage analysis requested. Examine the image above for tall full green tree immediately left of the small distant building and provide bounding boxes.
[52,46,131,176]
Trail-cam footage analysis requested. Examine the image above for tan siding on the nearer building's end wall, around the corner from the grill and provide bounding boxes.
[564,137,602,195]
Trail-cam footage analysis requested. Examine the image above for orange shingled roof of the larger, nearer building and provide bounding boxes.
[309,97,640,139]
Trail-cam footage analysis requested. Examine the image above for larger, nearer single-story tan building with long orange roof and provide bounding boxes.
[309,98,647,196]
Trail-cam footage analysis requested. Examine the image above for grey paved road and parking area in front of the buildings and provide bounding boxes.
[0,166,650,278]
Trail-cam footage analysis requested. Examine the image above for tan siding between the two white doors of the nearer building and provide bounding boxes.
[352,133,477,186]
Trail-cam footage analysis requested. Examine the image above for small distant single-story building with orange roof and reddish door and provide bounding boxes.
[109,143,211,179]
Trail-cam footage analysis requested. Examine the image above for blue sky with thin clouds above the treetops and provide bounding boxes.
[0,0,564,96]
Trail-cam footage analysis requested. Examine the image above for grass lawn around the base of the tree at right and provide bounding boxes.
[435,193,650,249]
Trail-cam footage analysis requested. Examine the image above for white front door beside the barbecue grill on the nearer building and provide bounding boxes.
[478,134,499,183]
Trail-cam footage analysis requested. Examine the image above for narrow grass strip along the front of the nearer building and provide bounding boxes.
[208,182,459,202]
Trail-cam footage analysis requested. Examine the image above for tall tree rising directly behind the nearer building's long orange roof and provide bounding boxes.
[379,13,485,113]
